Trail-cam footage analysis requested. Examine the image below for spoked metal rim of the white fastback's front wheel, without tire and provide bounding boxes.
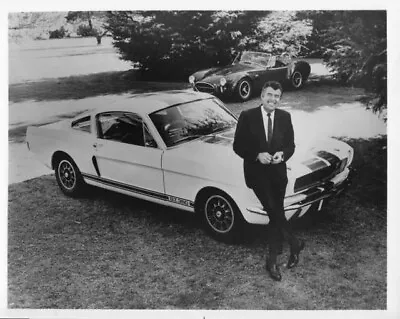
[204,195,235,234]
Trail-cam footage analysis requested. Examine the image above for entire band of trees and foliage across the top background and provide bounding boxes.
[9,10,387,111]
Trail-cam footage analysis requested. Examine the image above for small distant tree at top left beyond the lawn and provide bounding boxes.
[65,11,108,44]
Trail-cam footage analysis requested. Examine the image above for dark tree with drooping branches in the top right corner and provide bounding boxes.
[298,11,387,111]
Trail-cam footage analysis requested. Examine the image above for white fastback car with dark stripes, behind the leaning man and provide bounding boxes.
[26,91,353,242]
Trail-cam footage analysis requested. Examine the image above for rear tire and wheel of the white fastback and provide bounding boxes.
[55,155,85,197]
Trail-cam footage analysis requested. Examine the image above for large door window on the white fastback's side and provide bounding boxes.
[96,112,157,147]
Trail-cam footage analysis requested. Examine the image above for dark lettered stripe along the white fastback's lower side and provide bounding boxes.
[82,173,194,207]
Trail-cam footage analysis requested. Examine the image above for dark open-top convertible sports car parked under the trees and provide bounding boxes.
[189,51,311,101]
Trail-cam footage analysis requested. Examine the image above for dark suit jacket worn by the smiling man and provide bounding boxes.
[233,107,295,188]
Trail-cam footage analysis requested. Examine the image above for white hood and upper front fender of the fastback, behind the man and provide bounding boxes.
[163,129,351,195]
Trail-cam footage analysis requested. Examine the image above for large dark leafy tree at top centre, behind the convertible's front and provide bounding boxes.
[107,11,265,79]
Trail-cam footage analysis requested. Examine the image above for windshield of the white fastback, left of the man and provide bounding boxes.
[150,99,236,147]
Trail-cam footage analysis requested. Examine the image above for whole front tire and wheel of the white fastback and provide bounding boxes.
[198,191,247,244]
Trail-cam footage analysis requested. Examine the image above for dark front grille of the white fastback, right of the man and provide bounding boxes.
[294,151,347,193]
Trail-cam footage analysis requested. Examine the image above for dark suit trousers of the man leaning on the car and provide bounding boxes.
[252,164,299,263]
